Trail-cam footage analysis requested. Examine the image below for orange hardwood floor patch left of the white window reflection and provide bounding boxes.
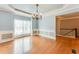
[0,41,13,54]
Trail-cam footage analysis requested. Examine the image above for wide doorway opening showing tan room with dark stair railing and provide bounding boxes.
[56,12,79,38]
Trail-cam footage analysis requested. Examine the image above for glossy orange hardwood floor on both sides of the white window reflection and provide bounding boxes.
[0,36,79,54]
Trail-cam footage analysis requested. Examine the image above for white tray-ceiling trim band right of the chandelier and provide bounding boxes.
[44,4,79,16]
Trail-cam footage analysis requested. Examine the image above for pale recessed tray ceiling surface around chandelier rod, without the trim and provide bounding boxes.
[0,4,64,13]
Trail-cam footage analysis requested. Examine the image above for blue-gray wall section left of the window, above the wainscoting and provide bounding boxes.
[0,11,14,31]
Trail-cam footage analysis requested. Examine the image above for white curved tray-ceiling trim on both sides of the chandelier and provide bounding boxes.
[0,4,79,17]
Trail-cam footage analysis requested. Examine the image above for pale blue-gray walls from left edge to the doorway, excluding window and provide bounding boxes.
[0,12,56,38]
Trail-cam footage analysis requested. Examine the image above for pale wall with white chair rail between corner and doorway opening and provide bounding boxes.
[39,15,56,38]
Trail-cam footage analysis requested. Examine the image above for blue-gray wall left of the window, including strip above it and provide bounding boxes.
[0,11,31,32]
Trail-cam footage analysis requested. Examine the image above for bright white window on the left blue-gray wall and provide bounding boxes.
[14,19,31,35]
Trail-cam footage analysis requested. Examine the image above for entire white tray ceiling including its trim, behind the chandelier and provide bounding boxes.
[0,4,79,16]
